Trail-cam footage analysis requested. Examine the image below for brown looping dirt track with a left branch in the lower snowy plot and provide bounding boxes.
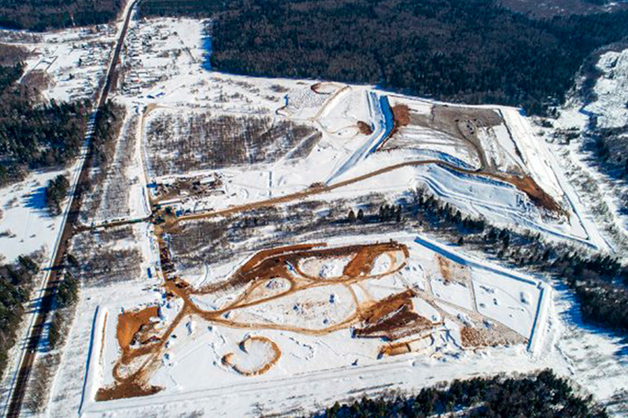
[96,239,409,401]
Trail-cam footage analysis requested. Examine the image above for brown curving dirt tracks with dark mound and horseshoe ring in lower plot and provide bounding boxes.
[96,242,418,401]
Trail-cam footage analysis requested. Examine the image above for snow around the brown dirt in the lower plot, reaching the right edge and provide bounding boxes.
[45,231,628,417]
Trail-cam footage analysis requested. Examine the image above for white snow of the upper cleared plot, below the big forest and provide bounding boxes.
[109,19,608,253]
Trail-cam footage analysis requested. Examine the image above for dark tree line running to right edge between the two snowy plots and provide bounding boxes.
[401,189,628,335]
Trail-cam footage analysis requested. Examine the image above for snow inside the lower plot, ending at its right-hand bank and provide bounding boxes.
[63,233,551,416]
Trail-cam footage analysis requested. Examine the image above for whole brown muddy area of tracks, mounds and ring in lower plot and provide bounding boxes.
[96,238,526,401]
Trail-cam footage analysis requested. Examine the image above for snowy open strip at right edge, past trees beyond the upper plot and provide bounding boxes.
[536,49,628,254]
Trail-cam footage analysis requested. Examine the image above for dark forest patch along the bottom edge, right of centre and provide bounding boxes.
[313,370,608,418]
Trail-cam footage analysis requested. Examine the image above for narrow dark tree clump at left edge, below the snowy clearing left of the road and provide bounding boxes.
[0,257,39,376]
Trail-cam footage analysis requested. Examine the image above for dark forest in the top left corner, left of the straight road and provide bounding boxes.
[0,0,125,31]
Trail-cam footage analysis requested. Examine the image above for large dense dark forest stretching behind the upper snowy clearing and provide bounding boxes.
[141,0,628,113]
